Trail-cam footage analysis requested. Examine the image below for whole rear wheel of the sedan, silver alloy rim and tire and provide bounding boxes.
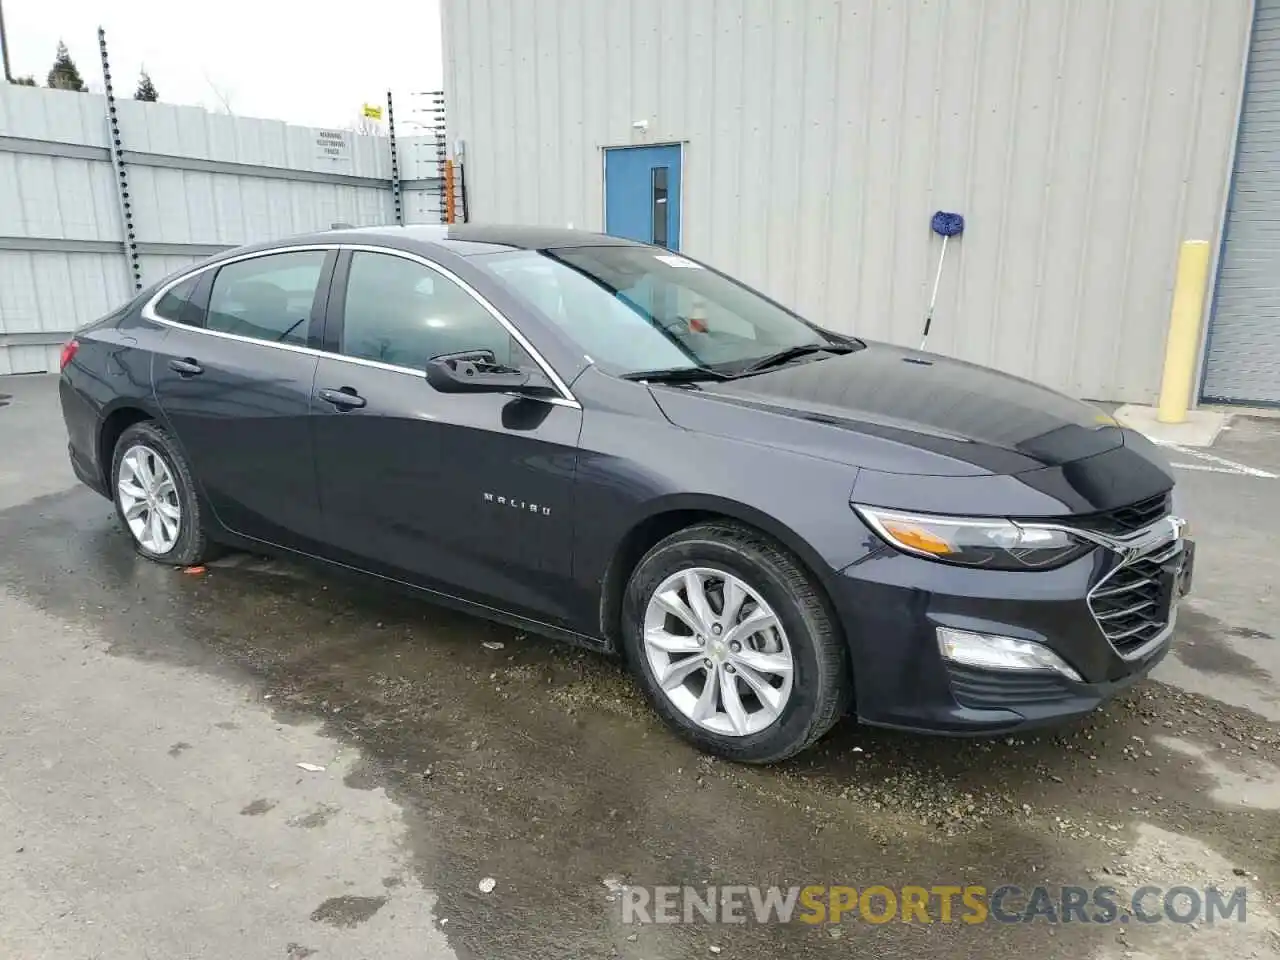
[111,420,207,566]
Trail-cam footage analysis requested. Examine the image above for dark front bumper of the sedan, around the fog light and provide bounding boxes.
[836,539,1194,735]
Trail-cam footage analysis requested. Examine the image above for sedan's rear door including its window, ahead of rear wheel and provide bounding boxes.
[152,248,337,553]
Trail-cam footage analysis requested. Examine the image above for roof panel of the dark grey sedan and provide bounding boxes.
[278,223,644,256]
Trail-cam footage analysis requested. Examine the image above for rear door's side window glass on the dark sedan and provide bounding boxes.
[205,250,325,346]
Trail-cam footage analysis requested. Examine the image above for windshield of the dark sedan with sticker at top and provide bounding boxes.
[474,244,847,376]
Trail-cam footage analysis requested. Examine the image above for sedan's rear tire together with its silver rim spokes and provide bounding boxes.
[111,420,210,567]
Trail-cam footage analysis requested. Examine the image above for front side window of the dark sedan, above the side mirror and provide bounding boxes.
[339,251,532,370]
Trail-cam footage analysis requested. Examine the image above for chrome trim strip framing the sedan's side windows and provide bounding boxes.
[142,243,582,410]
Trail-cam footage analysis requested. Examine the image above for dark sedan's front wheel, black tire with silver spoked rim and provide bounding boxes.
[622,521,852,763]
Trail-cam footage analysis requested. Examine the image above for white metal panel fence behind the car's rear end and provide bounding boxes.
[0,83,444,374]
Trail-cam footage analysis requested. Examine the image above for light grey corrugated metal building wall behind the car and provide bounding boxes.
[443,0,1252,402]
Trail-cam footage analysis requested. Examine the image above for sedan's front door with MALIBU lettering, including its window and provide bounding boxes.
[312,251,582,623]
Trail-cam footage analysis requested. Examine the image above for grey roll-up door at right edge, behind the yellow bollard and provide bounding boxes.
[1203,0,1280,403]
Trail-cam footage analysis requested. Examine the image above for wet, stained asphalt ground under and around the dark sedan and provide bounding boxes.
[0,376,1280,960]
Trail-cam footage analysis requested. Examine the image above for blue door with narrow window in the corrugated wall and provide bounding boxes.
[604,145,680,250]
